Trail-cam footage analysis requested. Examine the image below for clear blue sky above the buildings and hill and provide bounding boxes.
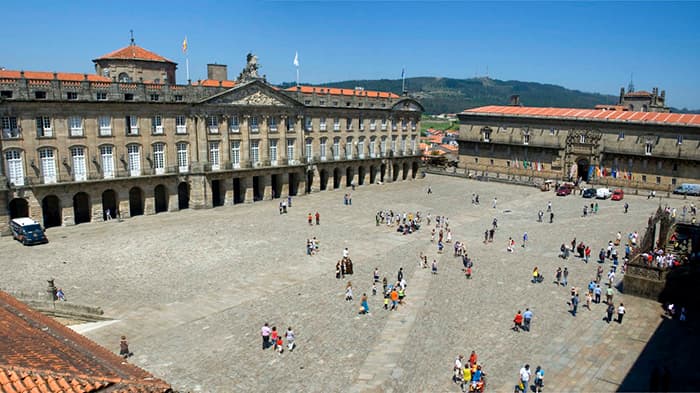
[0,0,700,108]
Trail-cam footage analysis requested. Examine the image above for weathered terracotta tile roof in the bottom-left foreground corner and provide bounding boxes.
[0,291,172,393]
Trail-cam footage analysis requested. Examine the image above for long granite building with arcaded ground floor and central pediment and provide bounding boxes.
[0,43,423,233]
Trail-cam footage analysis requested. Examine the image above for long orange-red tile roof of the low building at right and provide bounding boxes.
[462,105,700,126]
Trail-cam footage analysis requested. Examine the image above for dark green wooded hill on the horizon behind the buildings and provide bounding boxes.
[282,77,689,114]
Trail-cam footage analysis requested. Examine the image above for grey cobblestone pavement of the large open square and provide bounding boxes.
[0,175,681,392]
